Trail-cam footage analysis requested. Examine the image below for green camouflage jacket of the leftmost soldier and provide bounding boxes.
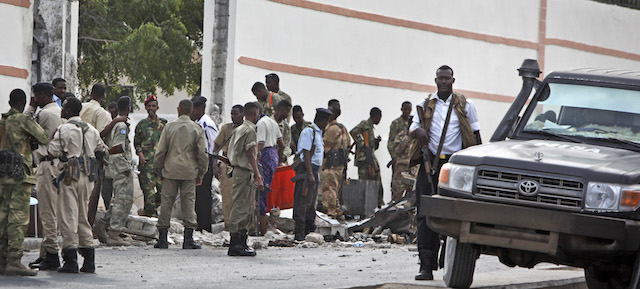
[0,108,49,184]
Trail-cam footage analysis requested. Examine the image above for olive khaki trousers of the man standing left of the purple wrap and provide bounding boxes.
[229,167,254,234]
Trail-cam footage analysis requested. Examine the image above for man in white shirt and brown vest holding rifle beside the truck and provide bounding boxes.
[409,65,482,280]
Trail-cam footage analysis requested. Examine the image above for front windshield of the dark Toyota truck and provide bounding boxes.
[524,83,640,144]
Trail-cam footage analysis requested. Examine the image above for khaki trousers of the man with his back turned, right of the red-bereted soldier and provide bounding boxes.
[156,178,198,229]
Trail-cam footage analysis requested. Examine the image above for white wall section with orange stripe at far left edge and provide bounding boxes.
[0,3,33,113]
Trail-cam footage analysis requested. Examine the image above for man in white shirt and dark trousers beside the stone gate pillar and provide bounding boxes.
[190,96,218,232]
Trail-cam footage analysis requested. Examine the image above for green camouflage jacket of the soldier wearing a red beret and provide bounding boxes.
[133,117,167,166]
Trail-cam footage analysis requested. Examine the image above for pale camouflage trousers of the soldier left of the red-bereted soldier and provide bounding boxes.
[102,173,133,232]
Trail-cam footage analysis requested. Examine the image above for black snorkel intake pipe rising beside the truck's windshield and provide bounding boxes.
[490,59,542,142]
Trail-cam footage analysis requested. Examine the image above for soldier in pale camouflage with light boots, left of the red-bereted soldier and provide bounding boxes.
[94,96,133,246]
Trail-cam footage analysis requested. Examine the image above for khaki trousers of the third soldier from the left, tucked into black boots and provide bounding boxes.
[57,173,93,249]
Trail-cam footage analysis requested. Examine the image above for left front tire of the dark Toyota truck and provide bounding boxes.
[444,237,480,289]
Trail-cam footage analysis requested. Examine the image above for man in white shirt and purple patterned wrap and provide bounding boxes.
[256,107,284,235]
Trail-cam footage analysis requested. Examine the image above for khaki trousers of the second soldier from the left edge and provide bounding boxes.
[36,161,60,258]
